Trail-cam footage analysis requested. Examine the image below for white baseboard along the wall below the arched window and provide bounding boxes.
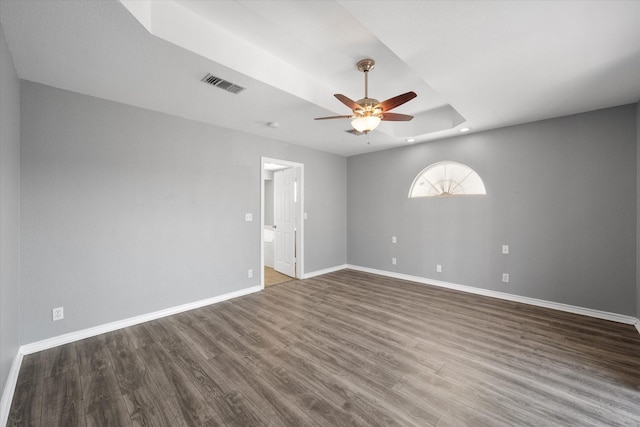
[347,264,640,332]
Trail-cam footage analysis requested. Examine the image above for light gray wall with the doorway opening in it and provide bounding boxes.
[21,81,346,343]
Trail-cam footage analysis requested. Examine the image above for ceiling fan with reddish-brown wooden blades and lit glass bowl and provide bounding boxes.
[316,59,418,133]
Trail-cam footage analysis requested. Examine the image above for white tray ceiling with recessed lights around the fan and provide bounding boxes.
[0,0,640,156]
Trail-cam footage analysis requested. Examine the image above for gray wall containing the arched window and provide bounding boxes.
[347,105,638,316]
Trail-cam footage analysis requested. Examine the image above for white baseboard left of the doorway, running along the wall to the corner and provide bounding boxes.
[20,286,262,354]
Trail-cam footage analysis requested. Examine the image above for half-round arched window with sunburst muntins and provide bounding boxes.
[409,160,487,199]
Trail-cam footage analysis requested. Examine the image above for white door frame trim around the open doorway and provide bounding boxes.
[260,157,305,289]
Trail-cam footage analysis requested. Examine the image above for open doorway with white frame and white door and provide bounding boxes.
[260,157,304,289]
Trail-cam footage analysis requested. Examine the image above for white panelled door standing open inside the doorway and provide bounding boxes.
[273,168,297,277]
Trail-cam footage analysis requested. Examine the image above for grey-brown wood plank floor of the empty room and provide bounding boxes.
[9,270,640,427]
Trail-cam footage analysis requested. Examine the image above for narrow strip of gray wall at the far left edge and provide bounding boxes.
[0,20,20,393]
